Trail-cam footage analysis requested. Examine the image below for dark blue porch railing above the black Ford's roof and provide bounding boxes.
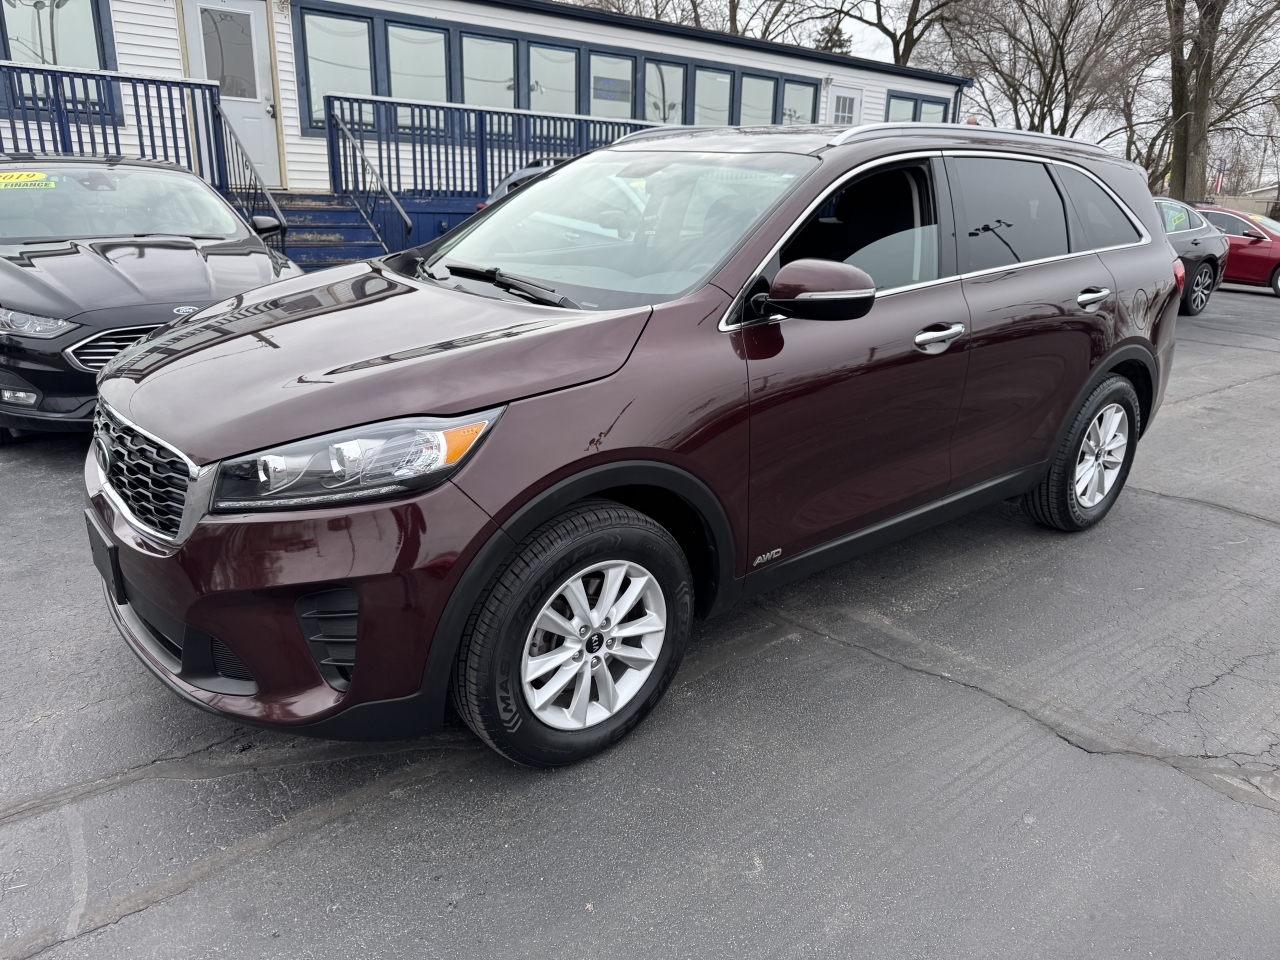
[0,60,227,191]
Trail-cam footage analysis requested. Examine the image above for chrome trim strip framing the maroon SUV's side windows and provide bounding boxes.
[717,146,1151,333]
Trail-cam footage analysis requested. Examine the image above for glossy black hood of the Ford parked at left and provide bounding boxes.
[0,237,280,325]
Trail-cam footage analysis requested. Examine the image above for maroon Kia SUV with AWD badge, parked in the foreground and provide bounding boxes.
[84,124,1179,765]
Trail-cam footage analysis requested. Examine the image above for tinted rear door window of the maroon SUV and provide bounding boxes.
[955,157,1068,270]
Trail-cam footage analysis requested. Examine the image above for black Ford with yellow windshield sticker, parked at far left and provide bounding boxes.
[0,156,302,443]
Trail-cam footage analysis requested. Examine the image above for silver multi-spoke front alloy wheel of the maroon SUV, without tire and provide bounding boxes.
[520,561,667,730]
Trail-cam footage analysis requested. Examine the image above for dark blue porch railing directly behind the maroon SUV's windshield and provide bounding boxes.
[324,95,654,200]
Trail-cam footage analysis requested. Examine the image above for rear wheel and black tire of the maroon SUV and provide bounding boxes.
[1023,375,1142,532]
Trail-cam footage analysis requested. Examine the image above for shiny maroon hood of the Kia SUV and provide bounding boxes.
[99,264,650,463]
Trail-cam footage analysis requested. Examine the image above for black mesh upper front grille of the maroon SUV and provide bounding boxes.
[95,403,191,536]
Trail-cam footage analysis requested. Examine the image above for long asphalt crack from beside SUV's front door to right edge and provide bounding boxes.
[751,603,1280,813]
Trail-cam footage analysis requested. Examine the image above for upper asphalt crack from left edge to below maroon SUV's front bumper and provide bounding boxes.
[0,731,470,827]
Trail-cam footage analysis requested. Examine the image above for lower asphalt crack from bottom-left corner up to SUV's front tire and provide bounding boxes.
[0,742,481,960]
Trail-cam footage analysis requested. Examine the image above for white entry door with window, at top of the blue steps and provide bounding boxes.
[183,0,280,187]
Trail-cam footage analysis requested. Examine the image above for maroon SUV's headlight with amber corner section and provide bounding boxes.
[214,410,502,511]
